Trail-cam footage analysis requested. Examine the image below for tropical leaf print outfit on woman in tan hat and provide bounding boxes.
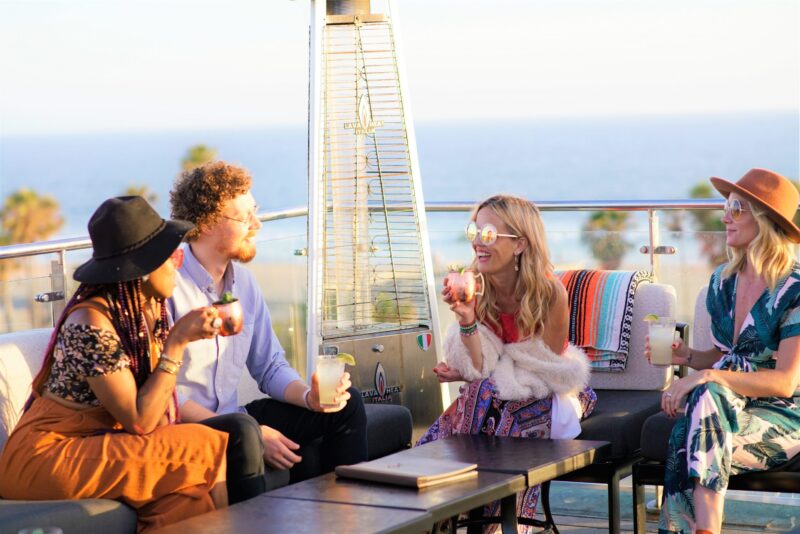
[658,264,800,534]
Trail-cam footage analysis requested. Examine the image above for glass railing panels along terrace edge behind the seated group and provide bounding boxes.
[0,200,724,342]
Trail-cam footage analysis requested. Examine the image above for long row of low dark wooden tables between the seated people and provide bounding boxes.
[153,435,609,534]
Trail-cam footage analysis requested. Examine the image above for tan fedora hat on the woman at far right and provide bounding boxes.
[711,169,800,243]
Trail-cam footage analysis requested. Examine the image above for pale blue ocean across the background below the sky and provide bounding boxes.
[0,111,800,237]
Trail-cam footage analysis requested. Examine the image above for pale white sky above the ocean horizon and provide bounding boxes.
[0,0,800,136]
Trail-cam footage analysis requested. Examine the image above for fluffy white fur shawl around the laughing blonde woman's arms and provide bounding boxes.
[444,323,589,400]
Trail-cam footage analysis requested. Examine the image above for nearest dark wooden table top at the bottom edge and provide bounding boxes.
[157,493,435,534]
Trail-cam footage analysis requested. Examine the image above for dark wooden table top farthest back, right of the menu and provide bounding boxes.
[395,434,611,486]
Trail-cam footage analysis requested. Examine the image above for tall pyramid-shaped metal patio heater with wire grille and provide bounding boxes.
[307,0,442,426]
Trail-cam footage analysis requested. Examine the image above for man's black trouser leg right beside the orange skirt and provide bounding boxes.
[200,413,267,504]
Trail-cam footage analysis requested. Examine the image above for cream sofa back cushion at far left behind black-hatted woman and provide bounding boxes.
[0,328,53,450]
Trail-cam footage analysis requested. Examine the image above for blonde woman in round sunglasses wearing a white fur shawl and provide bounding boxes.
[418,195,596,532]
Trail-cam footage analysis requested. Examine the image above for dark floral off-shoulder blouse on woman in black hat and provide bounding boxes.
[45,324,131,406]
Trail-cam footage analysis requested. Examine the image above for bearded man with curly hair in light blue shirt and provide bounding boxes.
[170,161,367,490]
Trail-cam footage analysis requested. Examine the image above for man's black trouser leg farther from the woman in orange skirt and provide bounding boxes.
[245,387,367,482]
